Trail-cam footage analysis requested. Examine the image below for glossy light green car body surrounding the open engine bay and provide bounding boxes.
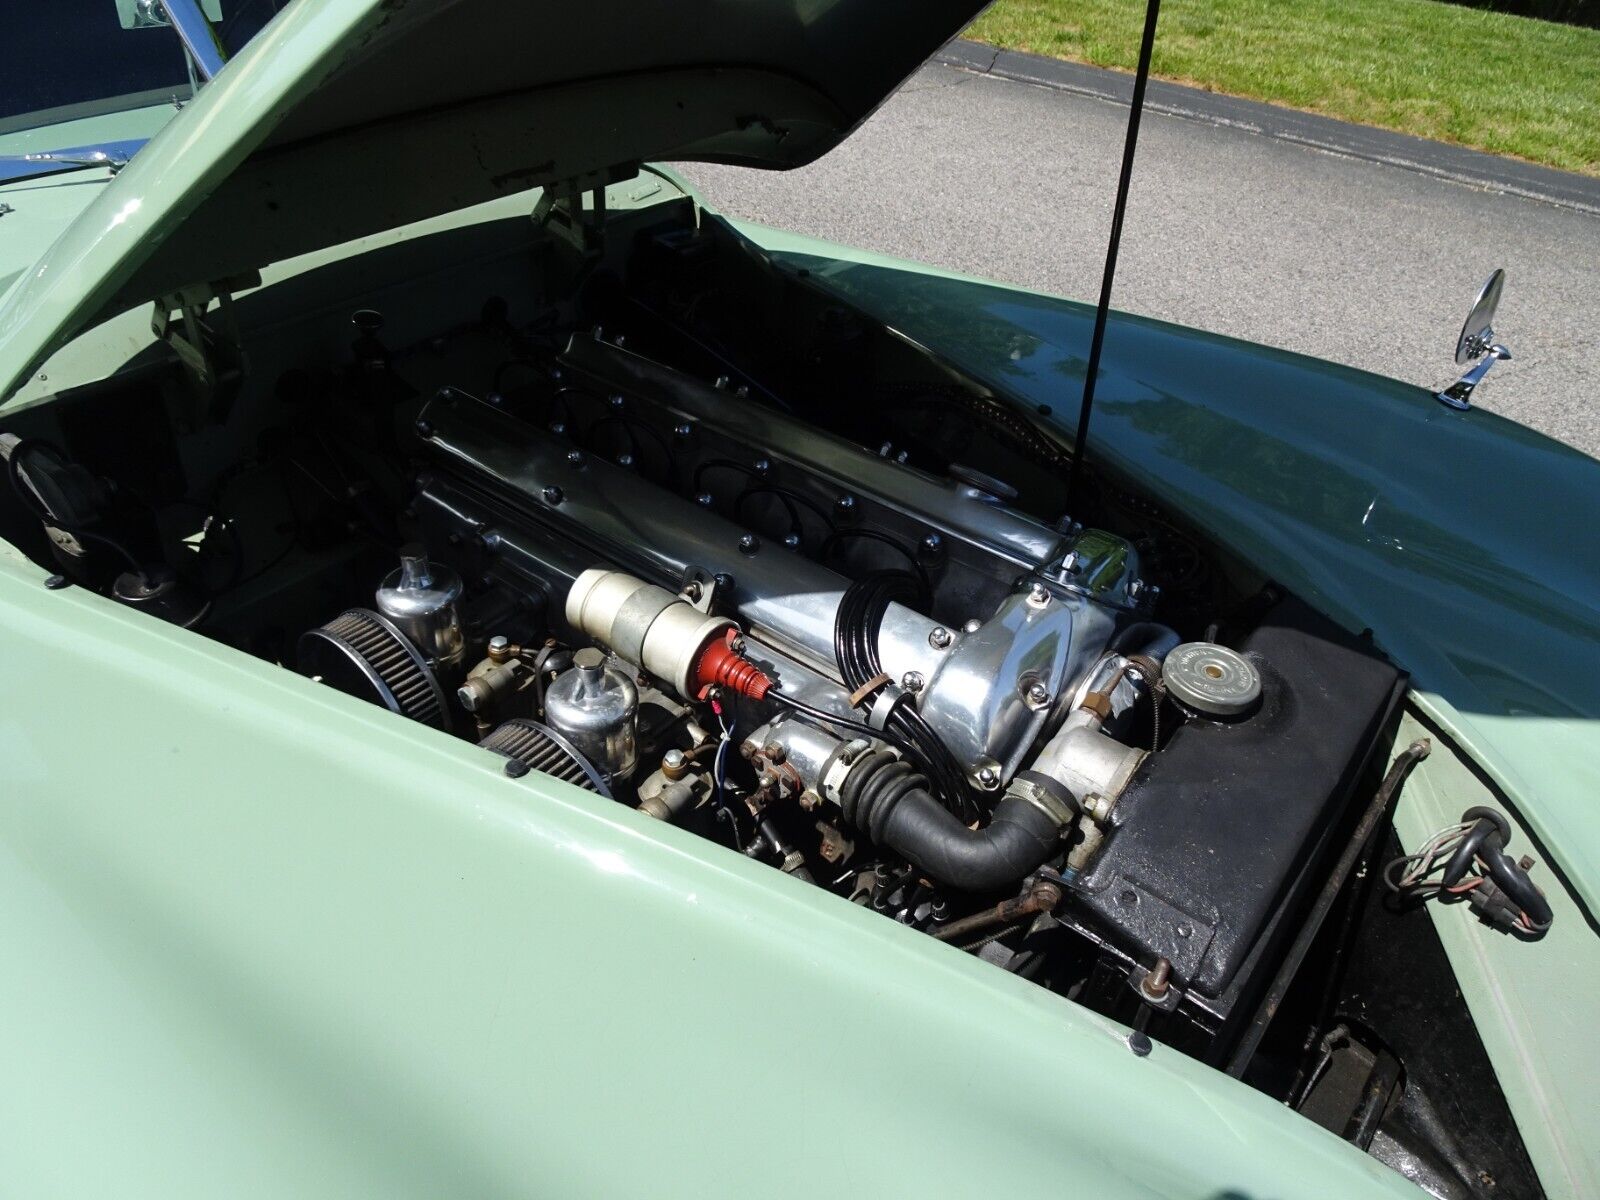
[0,3,1600,1198]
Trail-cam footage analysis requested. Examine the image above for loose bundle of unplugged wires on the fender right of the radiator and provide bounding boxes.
[1384,808,1554,941]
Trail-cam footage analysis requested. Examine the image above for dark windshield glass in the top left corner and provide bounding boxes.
[0,0,288,133]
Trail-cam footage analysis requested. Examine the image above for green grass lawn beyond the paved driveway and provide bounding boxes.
[968,0,1600,174]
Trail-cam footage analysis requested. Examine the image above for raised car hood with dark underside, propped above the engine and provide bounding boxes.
[0,0,982,397]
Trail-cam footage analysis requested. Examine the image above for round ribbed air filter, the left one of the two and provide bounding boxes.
[298,608,450,730]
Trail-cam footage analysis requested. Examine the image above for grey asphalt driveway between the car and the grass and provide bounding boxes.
[685,64,1600,458]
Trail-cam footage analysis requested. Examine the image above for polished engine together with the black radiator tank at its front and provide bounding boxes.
[291,334,1402,1046]
